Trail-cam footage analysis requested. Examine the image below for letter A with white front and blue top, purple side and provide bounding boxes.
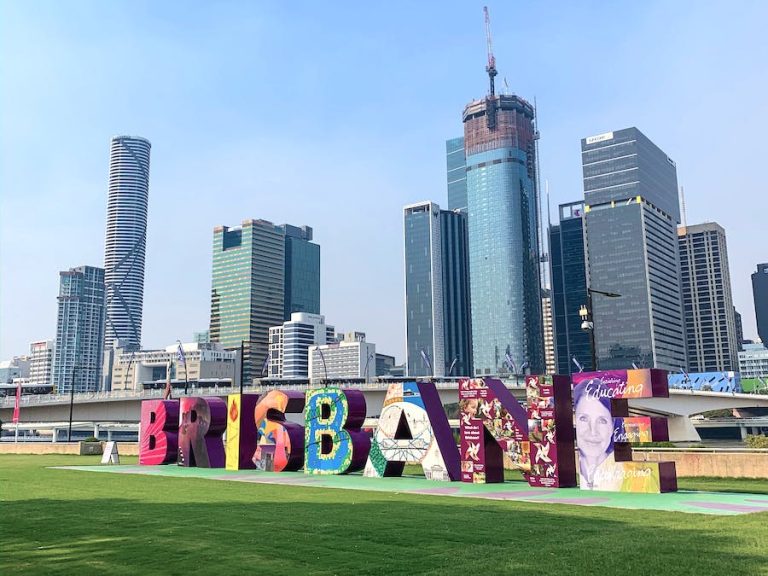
[365,382,461,481]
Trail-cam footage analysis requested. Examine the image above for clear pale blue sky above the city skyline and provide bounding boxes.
[0,0,768,362]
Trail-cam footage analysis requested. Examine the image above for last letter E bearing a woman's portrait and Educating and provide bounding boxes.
[572,369,677,493]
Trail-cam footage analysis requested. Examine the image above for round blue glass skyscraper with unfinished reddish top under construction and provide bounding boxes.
[463,86,544,375]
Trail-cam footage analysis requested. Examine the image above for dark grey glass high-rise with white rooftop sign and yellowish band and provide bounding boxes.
[581,128,687,371]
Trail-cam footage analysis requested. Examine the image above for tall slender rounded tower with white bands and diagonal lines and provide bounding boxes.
[104,136,151,349]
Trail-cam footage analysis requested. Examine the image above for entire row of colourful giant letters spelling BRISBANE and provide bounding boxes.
[139,369,677,493]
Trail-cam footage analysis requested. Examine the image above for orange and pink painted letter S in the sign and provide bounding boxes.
[250,390,304,472]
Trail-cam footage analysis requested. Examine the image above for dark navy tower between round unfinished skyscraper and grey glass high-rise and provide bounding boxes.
[549,201,594,374]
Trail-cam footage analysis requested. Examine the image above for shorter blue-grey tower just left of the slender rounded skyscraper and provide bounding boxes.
[53,266,105,394]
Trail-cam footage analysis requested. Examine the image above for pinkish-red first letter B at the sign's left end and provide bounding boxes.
[139,400,179,466]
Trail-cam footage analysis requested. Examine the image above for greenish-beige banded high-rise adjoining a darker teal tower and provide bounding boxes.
[210,220,285,383]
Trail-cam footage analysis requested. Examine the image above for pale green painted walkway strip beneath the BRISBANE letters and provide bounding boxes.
[59,465,768,515]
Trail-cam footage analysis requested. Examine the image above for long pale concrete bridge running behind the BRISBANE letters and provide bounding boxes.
[0,380,768,442]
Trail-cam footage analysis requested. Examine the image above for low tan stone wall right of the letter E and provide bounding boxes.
[632,450,768,478]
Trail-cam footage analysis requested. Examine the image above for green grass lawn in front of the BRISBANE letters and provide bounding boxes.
[0,456,768,576]
